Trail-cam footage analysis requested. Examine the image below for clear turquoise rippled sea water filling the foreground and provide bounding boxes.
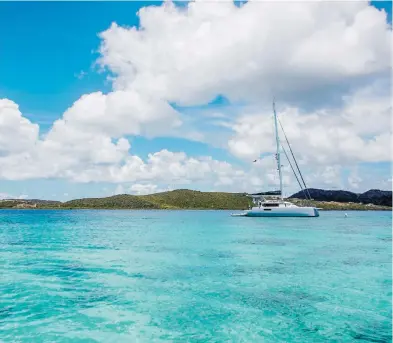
[0,210,392,343]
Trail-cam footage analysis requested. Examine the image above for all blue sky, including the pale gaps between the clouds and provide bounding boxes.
[0,1,392,198]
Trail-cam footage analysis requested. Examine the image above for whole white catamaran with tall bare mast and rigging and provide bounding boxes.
[232,102,319,217]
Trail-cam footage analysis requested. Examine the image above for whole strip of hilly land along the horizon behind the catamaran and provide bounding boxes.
[0,189,392,211]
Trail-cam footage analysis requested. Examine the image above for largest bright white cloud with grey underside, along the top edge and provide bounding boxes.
[100,1,392,104]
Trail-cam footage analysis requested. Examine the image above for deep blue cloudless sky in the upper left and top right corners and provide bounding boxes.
[0,1,386,124]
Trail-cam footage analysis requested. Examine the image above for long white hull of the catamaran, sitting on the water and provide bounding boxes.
[243,207,319,217]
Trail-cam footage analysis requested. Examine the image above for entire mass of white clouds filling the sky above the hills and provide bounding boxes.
[0,1,392,199]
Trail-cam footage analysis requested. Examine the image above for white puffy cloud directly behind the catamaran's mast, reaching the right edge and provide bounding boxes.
[228,82,392,165]
